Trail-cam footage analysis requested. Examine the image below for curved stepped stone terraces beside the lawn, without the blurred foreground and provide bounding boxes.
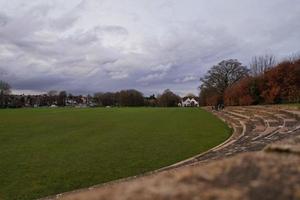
[189,106,300,162]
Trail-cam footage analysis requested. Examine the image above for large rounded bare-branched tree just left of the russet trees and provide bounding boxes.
[200,59,249,105]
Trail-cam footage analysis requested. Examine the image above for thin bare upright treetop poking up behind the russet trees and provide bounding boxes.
[250,55,276,76]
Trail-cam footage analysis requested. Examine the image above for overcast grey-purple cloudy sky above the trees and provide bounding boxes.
[0,0,300,95]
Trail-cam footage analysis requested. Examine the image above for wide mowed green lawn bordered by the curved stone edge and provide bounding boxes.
[0,108,231,200]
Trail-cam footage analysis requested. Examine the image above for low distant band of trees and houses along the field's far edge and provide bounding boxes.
[0,81,181,108]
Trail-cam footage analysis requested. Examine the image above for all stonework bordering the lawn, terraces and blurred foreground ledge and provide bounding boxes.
[44,107,300,200]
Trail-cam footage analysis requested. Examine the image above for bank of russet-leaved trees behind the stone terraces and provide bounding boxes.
[224,59,300,105]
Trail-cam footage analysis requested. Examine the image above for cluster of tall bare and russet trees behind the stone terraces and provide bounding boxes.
[200,55,300,106]
